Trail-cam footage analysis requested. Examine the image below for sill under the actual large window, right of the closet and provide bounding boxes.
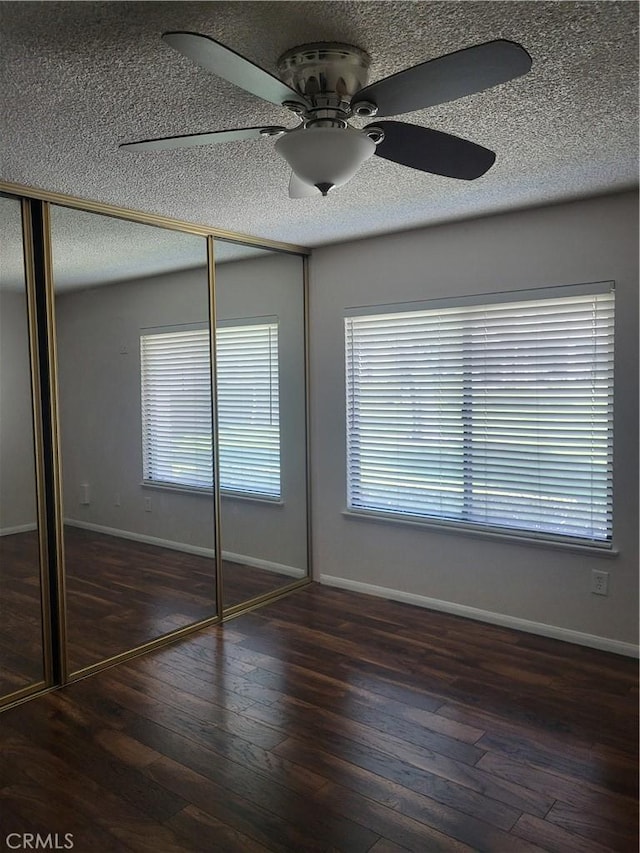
[342,509,620,559]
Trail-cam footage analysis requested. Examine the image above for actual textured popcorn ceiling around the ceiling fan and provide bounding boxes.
[0,2,638,253]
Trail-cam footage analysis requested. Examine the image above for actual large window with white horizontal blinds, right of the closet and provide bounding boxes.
[345,284,614,546]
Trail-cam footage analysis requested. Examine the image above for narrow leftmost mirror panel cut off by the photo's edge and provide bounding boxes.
[0,195,45,697]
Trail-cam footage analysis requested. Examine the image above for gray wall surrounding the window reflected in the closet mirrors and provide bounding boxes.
[56,255,307,568]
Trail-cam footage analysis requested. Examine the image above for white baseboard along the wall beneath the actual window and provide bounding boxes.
[319,574,639,657]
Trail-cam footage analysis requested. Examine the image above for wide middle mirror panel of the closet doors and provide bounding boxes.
[51,206,217,673]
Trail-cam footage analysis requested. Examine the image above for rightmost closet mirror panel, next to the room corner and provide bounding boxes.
[215,240,308,610]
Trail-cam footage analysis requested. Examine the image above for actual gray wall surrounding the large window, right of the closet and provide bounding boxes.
[310,193,638,650]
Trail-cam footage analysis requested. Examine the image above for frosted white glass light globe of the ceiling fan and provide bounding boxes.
[275,127,376,187]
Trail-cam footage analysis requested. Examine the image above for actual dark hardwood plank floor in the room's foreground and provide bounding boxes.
[0,584,638,853]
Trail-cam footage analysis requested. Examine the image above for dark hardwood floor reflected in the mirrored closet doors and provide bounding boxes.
[0,526,291,684]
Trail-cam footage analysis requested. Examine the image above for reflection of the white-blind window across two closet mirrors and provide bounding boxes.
[140,318,280,499]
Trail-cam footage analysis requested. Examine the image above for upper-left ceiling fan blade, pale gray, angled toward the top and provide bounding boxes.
[162,32,310,107]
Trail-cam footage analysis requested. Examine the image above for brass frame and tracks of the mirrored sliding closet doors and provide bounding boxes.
[0,182,312,710]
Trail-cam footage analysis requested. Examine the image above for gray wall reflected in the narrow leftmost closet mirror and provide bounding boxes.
[0,290,36,535]
